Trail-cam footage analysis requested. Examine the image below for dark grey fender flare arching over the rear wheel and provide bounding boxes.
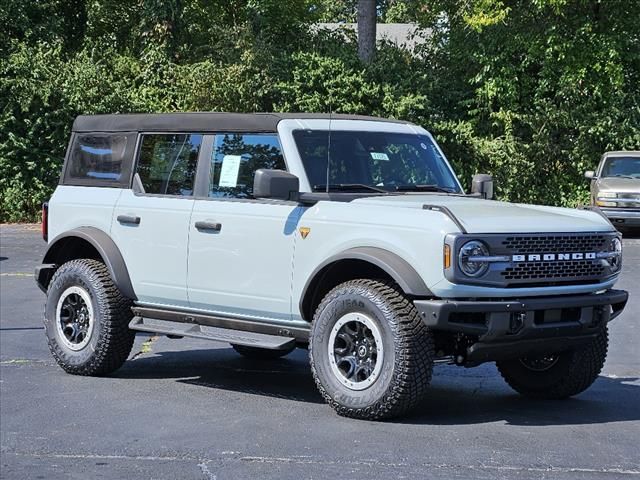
[36,227,138,300]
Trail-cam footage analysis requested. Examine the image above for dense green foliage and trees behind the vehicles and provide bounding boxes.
[0,0,640,221]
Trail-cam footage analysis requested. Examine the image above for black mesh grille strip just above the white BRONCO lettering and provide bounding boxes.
[502,235,611,255]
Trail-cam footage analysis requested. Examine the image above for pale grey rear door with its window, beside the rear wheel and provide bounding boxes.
[111,133,204,307]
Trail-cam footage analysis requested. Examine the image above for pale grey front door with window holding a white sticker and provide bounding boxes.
[187,134,301,320]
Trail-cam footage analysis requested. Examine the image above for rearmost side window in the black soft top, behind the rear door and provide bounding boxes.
[64,133,136,187]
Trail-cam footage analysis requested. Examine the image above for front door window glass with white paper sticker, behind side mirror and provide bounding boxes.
[209,133,286,198]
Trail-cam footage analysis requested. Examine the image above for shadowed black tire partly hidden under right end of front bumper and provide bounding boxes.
[496,326,608,400]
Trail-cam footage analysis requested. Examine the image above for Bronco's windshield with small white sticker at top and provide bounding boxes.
[293,130,461,193]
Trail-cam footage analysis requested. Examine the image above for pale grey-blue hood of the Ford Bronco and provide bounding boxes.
[352,194,613,233]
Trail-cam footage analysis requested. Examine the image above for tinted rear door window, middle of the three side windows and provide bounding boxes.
[136,134,202,196]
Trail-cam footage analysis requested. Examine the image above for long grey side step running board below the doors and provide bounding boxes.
[129,317,296,350]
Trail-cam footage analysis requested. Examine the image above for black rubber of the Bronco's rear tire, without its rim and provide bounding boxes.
[44,259,135,376]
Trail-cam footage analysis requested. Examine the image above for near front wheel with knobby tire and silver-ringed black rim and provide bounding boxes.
[309,279,434,420]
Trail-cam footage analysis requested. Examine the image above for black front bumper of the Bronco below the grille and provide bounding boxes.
[414,290,628,364]
